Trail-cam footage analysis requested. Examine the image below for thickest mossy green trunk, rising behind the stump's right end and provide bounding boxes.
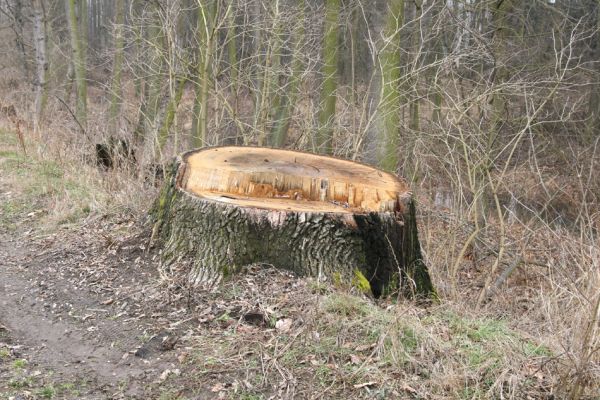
[379,0,404,171]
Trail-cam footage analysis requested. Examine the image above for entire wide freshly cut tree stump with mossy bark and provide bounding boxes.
[151,146,433,296]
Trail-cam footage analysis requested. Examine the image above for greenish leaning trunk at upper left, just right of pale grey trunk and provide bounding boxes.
[67,0,87,128]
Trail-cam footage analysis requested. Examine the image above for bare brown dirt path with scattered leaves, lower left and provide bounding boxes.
[0,223,183,398]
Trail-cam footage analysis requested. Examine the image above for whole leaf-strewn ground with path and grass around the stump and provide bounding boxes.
[0,132,592,400]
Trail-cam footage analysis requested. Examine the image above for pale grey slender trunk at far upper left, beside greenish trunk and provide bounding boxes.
[31,0,48,132]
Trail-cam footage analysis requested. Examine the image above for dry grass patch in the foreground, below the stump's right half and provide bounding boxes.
[166,278,551,399]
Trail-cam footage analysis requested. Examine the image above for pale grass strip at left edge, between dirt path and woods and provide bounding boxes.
[0,130,145,231]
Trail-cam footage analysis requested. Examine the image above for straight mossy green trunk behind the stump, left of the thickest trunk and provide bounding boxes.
[316,0,340,154]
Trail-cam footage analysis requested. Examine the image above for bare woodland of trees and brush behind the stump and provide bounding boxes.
[0,0,600,399]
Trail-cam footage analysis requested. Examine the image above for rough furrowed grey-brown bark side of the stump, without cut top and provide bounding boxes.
[151,147,433,296]
